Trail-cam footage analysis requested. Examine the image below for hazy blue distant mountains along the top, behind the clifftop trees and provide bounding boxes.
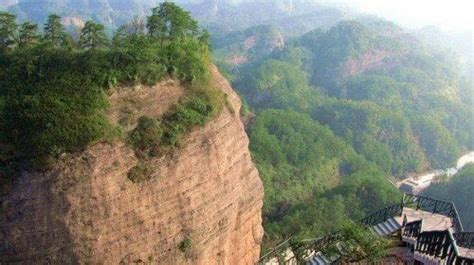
[0,0,344,36]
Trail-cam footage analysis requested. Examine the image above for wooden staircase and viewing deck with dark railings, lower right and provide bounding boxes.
[259,194,474,265]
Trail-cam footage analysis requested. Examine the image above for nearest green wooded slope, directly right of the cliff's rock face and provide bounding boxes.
[250,110,400,245]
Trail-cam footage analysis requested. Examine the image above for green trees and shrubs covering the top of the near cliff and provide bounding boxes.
[0,2,218,184]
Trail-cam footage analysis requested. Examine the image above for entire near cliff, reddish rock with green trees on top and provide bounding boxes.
[0,5,263,264]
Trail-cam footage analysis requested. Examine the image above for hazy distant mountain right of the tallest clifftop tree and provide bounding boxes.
[183,0,345,36]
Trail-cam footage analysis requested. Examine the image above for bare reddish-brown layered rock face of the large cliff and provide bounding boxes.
[0,69,263,264]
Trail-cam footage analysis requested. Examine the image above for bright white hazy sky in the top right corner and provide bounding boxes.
[334,0,474,30]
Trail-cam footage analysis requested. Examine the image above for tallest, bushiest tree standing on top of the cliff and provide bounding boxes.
[147,2,199,43]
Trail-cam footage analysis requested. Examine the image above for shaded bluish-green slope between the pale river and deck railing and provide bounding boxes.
[423,164,474,231]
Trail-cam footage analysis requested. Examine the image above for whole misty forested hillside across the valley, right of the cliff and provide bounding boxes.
[230,19,474,248]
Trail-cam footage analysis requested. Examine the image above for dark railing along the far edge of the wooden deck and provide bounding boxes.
[402,194,464,232]
